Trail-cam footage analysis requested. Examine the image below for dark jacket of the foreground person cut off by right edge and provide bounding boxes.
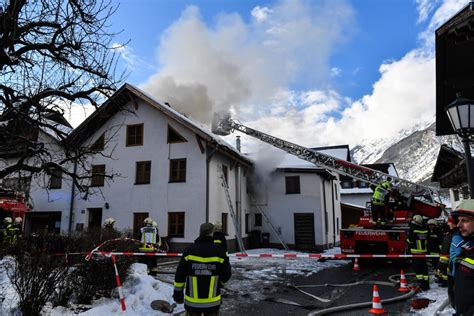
[454,239,474,315]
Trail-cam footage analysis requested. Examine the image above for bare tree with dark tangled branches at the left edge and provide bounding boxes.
[0,0,124,191]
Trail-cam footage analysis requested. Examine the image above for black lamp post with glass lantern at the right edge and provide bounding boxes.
[446,93,474,199]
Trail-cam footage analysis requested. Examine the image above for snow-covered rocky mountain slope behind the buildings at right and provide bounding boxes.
[351,123,464,182]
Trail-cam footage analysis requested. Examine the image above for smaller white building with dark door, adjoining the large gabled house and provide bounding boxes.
[250,146,348,250]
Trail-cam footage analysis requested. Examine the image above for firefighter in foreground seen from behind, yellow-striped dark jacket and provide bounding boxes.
[173,223,231,316]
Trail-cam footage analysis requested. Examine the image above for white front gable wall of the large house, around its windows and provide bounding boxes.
[73,100,206,242]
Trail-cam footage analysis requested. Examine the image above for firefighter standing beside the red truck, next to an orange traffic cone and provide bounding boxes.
[406,215,430,291]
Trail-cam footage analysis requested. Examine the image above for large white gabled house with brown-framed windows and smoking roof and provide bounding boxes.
[61,84,252,252]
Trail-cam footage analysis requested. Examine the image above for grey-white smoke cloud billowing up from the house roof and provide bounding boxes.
[143,0,352,125]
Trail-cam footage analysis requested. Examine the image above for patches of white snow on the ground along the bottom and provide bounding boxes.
[0,248,460,316]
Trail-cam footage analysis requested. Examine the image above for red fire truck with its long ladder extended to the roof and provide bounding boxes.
[212,113,444,255]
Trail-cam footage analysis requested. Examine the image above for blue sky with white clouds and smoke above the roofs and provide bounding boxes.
[68,0,468,153]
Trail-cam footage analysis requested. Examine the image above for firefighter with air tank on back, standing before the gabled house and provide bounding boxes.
[139,217,161,276]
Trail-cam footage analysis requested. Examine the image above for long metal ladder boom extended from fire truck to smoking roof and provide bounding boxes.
[212,115,434,201]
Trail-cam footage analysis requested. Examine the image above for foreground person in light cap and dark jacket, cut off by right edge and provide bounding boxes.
[451,199,474,315]
